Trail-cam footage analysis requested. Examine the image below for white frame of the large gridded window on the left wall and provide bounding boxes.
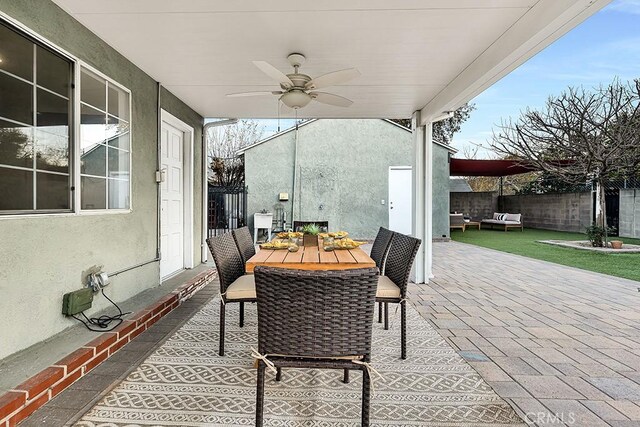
[0,11,134,221]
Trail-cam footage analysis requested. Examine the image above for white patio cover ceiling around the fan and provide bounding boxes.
[54,0,608,123]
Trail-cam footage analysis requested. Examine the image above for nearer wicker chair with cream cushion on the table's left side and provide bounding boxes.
[207,233,256,356]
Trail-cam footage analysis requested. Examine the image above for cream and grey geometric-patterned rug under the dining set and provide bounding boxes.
[76,299,524,427]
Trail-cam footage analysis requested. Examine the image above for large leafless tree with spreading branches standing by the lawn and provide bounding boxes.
[492,79,640,244]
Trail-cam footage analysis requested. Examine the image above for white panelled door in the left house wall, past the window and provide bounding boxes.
[160,122,184,278]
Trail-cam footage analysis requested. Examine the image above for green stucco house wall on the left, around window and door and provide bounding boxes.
[0,0,203,358]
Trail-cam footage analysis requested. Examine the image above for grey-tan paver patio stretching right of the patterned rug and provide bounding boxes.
[410,242,640,427]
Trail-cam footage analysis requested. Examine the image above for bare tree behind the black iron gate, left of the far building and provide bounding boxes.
[207,120,264,185]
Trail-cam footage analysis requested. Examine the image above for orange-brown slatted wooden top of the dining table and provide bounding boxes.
[246,242,376,273]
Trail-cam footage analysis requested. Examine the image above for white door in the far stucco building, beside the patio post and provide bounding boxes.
[389,166,412,234]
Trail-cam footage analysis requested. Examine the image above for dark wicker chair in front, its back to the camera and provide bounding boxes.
[254,266,378,427]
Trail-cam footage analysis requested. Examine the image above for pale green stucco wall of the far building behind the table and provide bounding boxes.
[245,119,449,239]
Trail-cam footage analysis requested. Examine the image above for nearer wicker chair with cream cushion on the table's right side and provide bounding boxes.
[376,233,421,359]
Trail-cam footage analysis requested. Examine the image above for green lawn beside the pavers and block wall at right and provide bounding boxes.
[451,228,640,281]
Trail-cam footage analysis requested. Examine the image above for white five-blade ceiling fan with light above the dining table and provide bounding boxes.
[227,53,360,110]
